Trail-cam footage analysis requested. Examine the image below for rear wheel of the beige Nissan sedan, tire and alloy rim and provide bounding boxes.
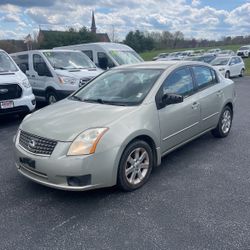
[211,106,233,138]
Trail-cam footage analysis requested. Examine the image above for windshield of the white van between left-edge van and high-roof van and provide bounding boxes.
[43,51,96,70]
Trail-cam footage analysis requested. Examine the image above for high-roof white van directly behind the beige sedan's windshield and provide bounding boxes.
[54,42,143,70]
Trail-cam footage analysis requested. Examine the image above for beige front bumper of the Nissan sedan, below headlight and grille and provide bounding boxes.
[15,139,118,191]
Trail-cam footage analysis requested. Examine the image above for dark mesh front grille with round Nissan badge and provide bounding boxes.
[19,131,57,156]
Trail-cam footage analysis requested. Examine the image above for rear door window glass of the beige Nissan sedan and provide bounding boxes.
[192,66,216,89]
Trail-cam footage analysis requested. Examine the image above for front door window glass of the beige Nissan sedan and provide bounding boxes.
[163,68,194,96]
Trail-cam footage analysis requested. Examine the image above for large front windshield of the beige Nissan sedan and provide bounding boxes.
[70,68,163,106]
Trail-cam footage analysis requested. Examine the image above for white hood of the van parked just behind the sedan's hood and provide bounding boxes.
[55,68,103,79]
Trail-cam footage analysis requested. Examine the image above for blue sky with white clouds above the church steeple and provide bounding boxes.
[0,0,250,40]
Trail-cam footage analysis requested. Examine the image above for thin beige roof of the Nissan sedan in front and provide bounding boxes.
[114,61,211,70]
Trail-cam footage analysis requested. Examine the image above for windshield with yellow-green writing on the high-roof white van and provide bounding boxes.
[109,50,143,65]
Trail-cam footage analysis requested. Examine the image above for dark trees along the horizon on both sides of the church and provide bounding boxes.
[0,27,250,53]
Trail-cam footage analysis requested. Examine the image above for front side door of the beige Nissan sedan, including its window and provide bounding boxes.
[157,67,200,153]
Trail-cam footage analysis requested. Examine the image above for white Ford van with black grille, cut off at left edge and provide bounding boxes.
[0,49,36,115]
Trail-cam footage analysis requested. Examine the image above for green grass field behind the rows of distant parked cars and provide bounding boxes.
[140,45,250,76]
